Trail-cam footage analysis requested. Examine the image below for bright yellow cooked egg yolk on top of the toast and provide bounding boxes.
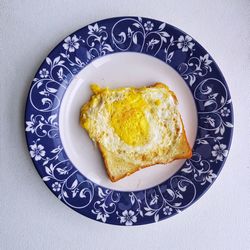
[108,90,149,146]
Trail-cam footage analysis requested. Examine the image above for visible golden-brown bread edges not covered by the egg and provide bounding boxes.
[80,83,192,182]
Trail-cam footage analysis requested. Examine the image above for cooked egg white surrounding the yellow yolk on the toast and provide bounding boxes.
[83,88,182,164]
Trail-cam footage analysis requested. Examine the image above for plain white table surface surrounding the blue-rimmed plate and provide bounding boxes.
[0,0,250,250]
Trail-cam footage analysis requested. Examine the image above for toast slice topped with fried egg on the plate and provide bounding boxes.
[80,83,192,182]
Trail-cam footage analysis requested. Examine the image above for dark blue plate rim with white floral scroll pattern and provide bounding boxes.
[25,17,233,226]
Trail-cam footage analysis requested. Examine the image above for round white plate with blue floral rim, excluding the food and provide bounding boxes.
[25,17,233,226]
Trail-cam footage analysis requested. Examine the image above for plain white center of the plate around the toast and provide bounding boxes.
[59,52,197,191]
